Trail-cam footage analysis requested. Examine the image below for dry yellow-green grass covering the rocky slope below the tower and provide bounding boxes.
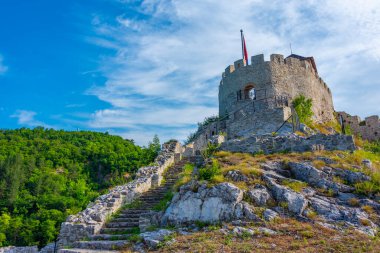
[142,140,380,252]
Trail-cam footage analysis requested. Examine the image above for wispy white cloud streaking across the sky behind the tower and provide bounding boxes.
[84,0,380,142]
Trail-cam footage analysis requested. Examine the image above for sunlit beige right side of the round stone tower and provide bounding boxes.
[270,54,335,123]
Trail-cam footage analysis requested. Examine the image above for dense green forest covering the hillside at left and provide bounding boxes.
[0,127,160,247]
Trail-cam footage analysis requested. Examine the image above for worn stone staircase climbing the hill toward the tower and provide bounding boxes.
[59,159,189,253]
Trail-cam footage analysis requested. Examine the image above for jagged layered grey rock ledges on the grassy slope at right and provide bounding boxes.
[263,162,380,236]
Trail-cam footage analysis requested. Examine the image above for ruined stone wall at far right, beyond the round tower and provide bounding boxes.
[338,112,380,141]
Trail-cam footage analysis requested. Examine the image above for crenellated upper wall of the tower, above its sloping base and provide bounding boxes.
[219,54,334,123]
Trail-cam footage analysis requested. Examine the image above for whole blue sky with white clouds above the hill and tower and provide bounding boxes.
[0,0,380,145]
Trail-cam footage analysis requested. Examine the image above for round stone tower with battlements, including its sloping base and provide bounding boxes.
[218,54,334,138]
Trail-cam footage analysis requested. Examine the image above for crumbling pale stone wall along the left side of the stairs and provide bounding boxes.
[58,142,181,247]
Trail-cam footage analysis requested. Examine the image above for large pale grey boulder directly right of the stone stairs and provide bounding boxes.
[163,182,257,224]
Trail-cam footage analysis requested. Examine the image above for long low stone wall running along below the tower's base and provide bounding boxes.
[220,134,356,154]
